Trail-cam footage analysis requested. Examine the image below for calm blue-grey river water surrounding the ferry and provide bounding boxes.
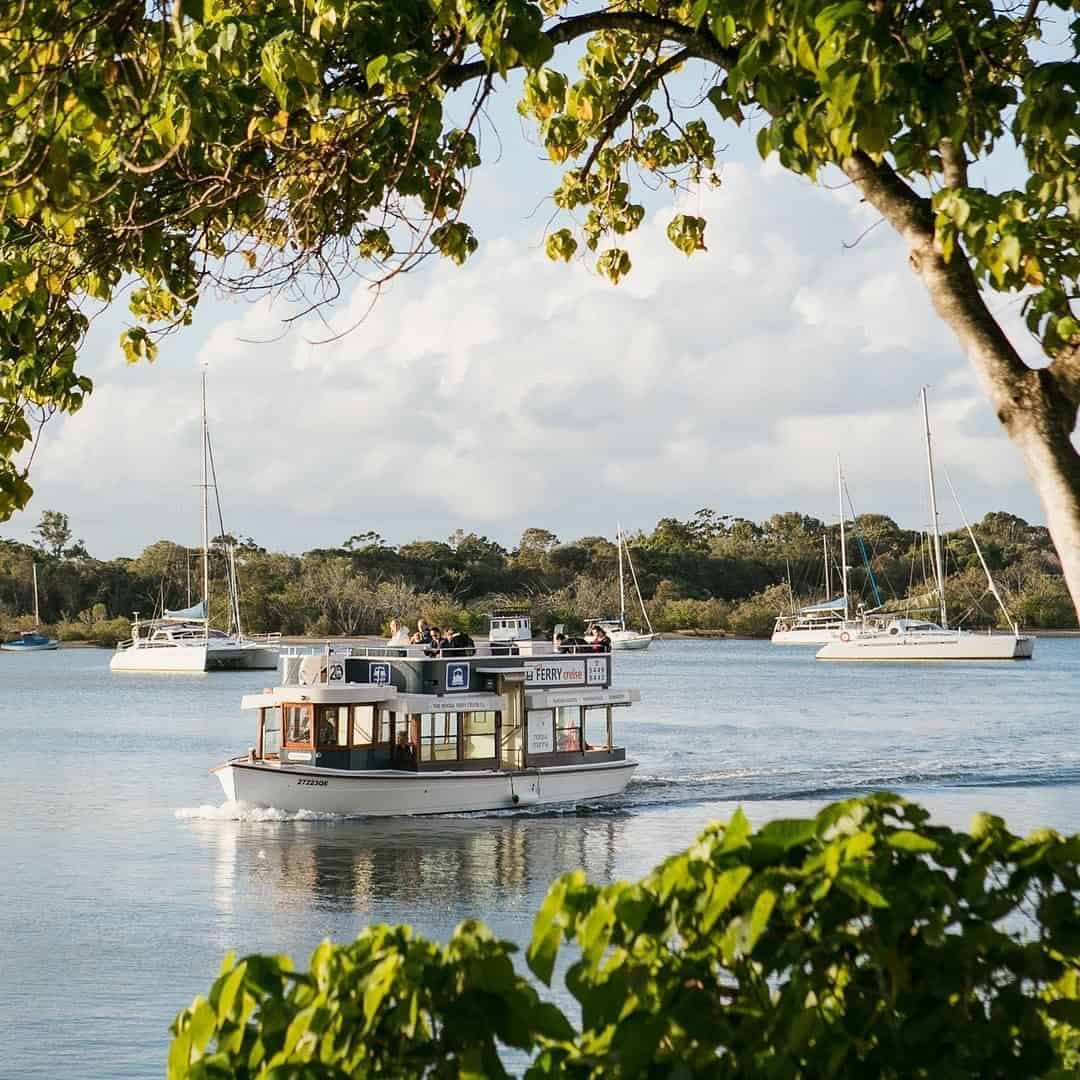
[0,638,1080,1080]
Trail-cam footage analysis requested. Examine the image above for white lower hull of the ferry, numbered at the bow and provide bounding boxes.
[214,758,637,818]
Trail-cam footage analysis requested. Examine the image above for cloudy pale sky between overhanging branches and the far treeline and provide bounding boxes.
[0,76,1042,558]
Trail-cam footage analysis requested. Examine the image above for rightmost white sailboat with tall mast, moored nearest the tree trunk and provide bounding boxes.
[818,387,1035,661]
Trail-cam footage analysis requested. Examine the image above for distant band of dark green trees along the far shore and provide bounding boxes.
[0,510,1077,642]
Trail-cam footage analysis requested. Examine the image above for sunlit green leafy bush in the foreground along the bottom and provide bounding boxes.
[168,794,1080,1080]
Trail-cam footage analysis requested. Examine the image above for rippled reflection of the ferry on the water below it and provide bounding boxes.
[191,812,627,920]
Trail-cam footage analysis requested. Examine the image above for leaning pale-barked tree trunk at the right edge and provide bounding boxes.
[843,154,1080,615]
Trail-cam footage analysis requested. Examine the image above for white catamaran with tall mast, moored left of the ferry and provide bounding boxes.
[109,372,281,672]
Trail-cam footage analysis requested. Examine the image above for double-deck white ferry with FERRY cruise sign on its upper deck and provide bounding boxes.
[212,615,640,816]
